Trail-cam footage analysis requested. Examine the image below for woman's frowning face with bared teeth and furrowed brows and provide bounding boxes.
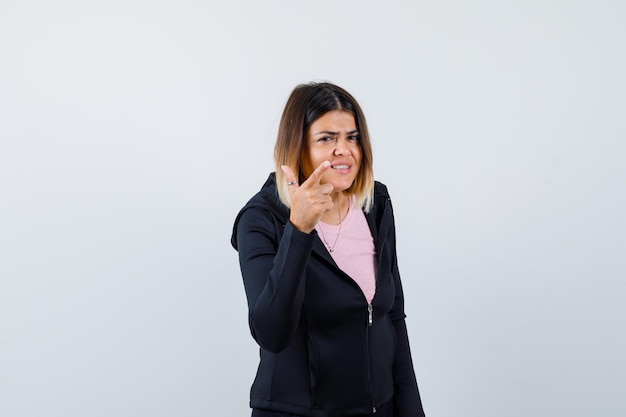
[302,110,361,192]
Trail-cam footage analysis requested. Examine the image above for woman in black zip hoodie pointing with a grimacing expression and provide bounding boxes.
[232,83,424,417]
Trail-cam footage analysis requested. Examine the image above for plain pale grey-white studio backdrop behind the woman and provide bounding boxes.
[0,0,626,417]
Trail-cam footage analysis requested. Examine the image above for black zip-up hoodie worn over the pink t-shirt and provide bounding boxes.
[231,174,424,417]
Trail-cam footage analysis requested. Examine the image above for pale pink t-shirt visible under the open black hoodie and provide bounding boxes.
[315,199,376,303]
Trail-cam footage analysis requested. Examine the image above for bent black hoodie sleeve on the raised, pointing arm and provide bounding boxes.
[236,208,315,353]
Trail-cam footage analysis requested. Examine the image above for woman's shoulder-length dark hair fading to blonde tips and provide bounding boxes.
[274,82,374,212]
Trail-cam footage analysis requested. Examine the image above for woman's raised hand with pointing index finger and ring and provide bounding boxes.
[281,161,334,233]
